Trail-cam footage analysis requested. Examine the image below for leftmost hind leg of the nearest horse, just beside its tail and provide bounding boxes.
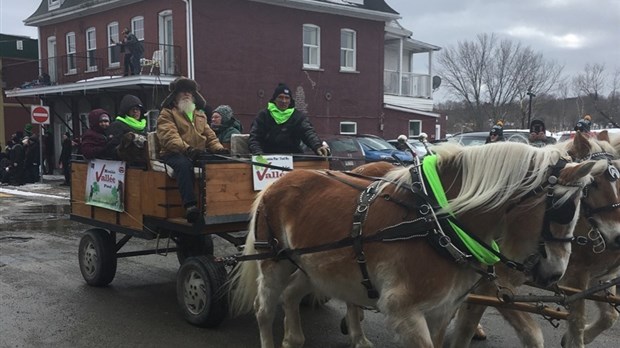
[254,260,295,348]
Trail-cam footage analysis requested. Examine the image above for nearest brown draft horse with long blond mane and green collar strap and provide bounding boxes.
[230,143,594,348]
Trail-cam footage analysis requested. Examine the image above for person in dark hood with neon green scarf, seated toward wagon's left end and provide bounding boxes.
[105,94,147,160]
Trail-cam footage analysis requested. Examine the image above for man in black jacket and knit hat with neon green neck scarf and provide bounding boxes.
[249,83,329,156]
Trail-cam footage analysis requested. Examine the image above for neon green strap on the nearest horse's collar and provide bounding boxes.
[422,155,500,266]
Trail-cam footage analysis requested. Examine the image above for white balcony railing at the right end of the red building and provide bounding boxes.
[383,70,432,99]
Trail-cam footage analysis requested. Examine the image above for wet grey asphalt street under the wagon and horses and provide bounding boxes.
[0,191,620,348]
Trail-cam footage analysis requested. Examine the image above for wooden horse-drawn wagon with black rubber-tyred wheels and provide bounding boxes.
[70,133,328,326]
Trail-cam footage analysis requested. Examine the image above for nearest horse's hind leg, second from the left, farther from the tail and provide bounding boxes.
[282,270,312,348]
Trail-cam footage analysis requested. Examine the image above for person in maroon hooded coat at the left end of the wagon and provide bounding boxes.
[80,109,114,159]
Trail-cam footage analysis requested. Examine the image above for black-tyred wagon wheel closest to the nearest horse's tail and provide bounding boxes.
[177,256,227,327]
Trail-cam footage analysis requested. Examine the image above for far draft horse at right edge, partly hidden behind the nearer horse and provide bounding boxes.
[451,131,620,348]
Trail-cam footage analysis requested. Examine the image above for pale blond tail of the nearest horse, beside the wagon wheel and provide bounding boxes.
[227,190,266,317]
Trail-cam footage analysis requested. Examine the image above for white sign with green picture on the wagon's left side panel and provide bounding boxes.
[84,159,126,212]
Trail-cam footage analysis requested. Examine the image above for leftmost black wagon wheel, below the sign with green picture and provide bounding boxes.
[78,228,116,286]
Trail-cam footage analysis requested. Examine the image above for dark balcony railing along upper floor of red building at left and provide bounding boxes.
[7,42,183,89]
